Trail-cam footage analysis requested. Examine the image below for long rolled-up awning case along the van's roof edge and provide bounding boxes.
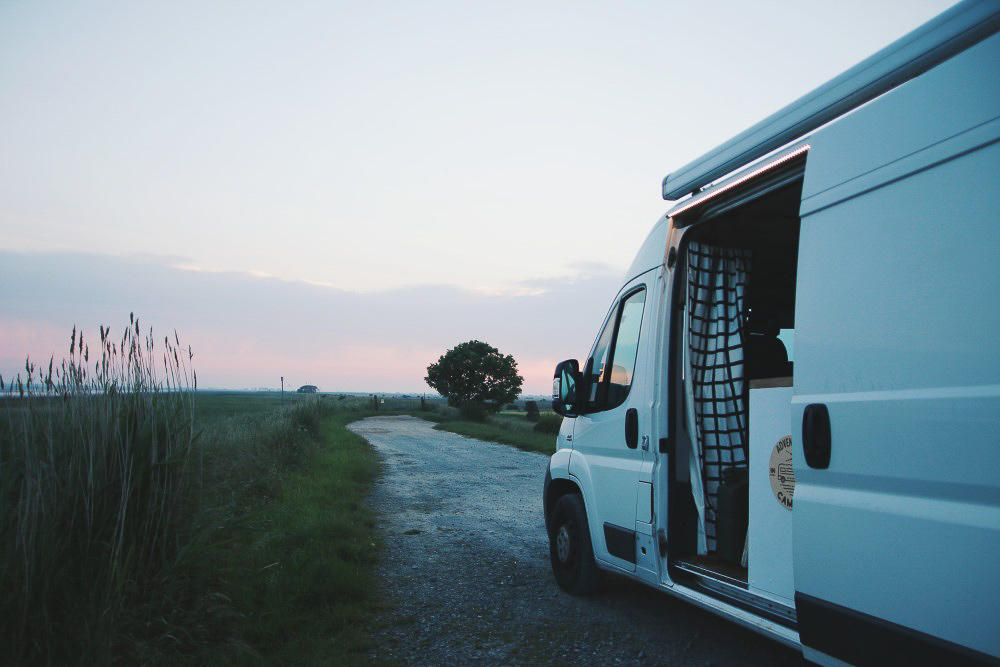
[663,0,1000,200]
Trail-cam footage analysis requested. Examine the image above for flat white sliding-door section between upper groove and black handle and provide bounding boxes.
[795,144,1000,395]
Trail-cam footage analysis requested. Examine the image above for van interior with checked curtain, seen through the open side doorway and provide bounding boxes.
[665,172,802,625]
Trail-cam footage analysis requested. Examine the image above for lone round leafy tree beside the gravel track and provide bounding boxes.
[424,340,524,420]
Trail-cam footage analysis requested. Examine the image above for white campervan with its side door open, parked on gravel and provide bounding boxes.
[544,0,1000,664]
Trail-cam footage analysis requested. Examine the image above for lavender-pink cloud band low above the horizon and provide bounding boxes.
[0,252,620,393]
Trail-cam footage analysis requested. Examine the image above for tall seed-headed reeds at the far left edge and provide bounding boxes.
[0,316,198,665]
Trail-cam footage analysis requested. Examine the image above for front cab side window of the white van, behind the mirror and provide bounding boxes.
[586,289,646,412]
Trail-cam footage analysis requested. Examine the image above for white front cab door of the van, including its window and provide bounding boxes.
[570,280,648,571]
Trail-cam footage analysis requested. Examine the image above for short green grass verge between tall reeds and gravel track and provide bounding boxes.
[205,411,380,665]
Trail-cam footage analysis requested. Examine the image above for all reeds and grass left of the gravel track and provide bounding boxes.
[0,319,398,665]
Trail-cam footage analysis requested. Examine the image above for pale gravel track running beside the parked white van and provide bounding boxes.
[348,417,805,666]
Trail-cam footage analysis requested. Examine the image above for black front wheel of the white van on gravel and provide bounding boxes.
[549,493,602,595]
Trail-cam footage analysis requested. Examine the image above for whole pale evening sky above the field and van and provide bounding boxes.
[0,0,952,394]
